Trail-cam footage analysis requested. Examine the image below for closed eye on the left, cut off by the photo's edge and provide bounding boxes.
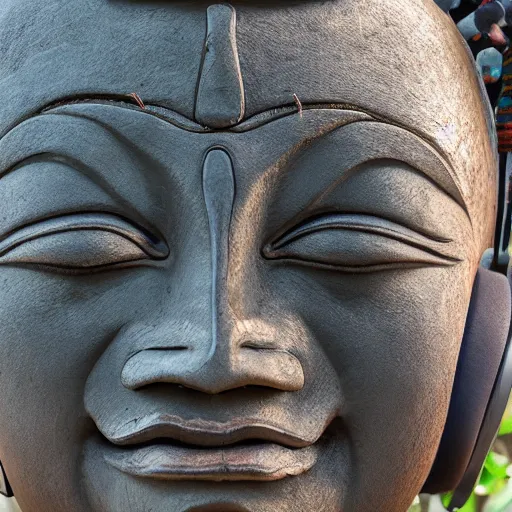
[0,213,169,270]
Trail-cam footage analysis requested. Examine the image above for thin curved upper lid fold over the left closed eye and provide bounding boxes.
[0,213,169,260]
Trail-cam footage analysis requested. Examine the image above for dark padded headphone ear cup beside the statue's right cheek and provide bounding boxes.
[422,268,512,507]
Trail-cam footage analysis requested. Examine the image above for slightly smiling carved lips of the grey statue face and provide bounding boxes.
[104,416,319,482]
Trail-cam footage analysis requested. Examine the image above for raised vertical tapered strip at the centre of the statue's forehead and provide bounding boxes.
[194,5,245,129]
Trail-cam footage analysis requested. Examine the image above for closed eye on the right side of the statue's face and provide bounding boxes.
[263,214,461,272]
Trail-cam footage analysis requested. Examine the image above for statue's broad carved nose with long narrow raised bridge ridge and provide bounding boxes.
[121,149,304,394]
